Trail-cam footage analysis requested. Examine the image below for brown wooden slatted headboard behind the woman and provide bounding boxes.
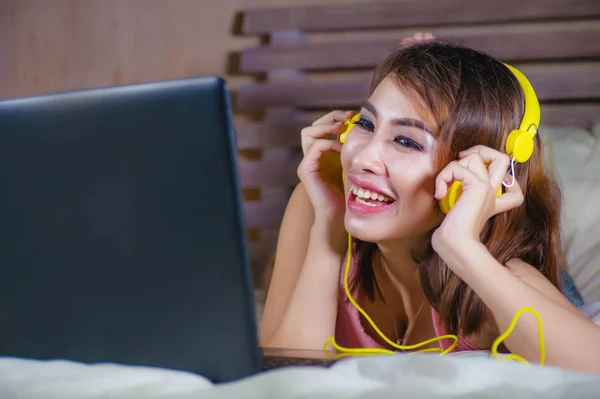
[235,0,600,284]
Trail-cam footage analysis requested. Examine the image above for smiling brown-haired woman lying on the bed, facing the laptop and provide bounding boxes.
[260,37,600,372]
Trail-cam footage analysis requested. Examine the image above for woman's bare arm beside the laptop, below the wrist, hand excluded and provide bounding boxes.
[260,184,345,349]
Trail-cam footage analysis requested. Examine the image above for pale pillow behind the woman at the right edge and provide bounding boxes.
[540,125,600,303]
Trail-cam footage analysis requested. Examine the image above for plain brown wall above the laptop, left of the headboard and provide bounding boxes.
[0,0,368,98]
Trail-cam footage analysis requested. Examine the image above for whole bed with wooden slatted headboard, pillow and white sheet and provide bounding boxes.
[0,0,600,399]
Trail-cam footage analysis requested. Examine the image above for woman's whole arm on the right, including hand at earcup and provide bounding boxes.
[431,146,600,372]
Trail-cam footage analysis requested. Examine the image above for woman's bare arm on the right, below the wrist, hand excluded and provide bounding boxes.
[443,241,600,373]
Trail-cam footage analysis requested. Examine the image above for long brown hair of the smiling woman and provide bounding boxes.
[352,40,561,335]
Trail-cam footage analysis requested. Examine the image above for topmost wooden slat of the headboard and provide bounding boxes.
[242,0,600,35]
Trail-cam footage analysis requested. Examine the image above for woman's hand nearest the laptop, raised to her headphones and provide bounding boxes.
[298,111,352,224]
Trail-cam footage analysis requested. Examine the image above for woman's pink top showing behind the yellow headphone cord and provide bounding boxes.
[335,260,480,352]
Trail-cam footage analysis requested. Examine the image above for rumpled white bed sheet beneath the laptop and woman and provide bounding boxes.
[0,302,600,399]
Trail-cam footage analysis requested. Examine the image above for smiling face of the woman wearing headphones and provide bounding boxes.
[341,78,441,243]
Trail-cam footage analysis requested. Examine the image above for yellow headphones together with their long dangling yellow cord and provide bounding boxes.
[330,64,546,365]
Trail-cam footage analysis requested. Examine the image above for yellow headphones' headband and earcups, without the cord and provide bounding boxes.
[339,64,540,214]
